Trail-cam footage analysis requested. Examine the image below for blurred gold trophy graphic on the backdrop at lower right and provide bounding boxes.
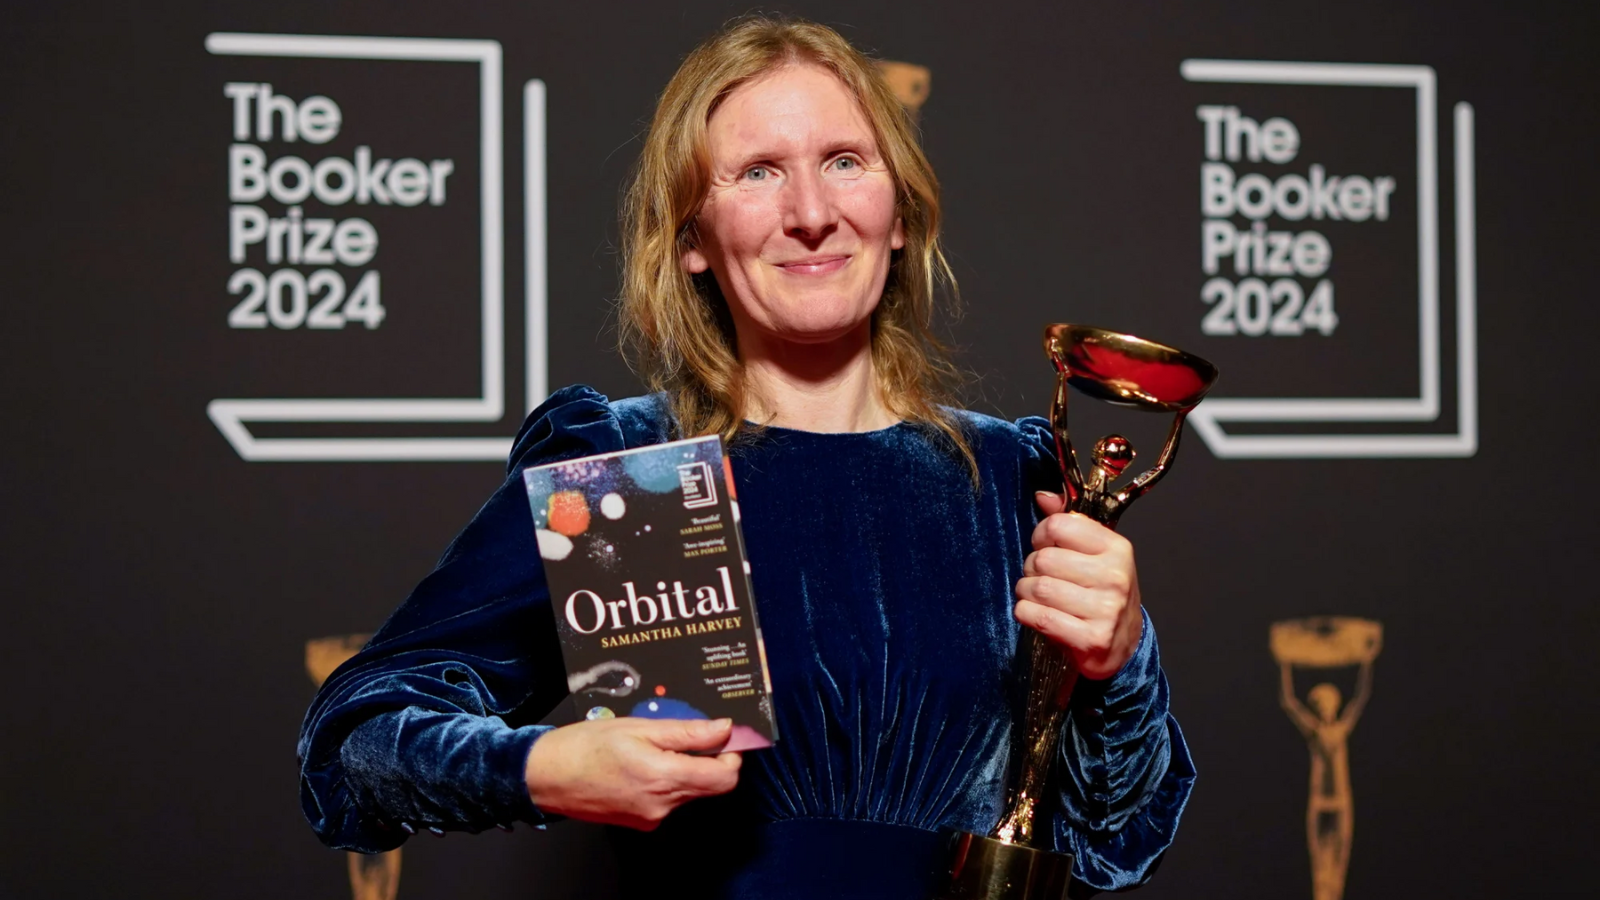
[1270,617,1384,900]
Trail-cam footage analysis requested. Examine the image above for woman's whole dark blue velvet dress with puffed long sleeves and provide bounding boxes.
[299,386,1194,900]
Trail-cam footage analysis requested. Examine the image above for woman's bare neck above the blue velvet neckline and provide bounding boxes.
[739,322,899,432]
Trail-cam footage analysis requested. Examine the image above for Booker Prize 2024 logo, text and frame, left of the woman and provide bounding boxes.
[205,34,546,461]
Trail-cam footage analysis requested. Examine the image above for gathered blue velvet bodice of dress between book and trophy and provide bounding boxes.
[731,424,1032,830]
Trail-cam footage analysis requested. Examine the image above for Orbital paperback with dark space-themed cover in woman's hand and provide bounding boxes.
[523,437,778,749]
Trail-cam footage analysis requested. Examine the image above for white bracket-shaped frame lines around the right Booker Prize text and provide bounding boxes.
[1179,59,1478,460]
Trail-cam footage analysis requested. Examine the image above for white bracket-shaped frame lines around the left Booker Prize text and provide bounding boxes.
[205,32,547,461]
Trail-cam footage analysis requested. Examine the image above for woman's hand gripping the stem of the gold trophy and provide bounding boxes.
[1014,492,1144,679]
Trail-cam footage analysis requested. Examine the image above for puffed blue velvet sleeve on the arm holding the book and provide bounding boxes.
[298,386,646,852]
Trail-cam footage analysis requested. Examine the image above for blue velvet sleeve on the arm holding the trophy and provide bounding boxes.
[1018,416,1195,890]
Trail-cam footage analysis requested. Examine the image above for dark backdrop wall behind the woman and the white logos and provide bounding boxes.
[0,0,1600,898]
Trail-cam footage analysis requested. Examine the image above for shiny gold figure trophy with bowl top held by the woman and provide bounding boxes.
[939,325,1216,900]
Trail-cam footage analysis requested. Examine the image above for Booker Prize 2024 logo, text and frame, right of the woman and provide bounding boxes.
[1181,59,1477,458]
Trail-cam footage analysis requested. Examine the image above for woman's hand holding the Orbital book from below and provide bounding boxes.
[523,717,741,831]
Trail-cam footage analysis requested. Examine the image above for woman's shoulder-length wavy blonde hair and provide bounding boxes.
[619,16,976,476]
